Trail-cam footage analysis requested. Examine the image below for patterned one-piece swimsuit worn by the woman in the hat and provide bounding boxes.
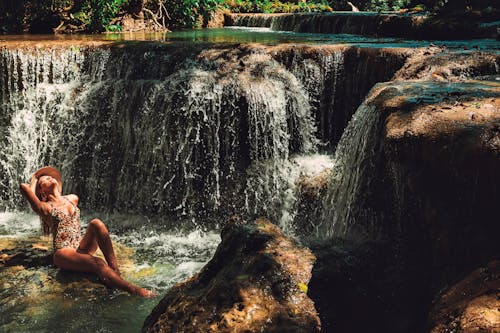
[49,197,82,251]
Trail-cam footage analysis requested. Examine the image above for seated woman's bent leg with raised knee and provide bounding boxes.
[78,219,120,275]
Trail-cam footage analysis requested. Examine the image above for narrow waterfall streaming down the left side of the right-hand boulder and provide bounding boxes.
[317,86,395,238]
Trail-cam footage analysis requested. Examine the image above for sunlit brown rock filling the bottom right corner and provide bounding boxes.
[428,260,500,333]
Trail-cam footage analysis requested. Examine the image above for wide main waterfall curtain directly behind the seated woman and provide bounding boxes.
[0,47,318,227]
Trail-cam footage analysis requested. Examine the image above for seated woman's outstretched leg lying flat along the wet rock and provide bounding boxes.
[54,248,155,297]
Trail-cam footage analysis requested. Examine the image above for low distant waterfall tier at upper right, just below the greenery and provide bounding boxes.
[225,12,496,40]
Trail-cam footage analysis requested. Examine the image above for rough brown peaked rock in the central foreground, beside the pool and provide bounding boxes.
[143,219,320,333]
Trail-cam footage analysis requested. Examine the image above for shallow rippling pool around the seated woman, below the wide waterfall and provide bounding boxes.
[0,212,220,332]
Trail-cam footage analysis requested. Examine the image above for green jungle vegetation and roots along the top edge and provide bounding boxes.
[0,0,497,33]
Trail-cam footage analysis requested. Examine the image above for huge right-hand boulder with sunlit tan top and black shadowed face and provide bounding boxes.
[311,81,500,332]
